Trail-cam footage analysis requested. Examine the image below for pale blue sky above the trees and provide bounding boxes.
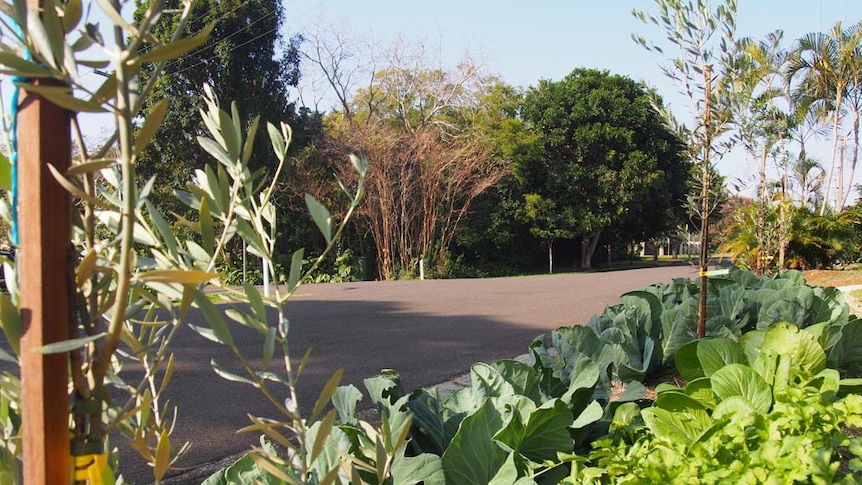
[284,0,862,197]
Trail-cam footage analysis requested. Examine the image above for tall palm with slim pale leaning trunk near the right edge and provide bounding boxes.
[788,22,862,214]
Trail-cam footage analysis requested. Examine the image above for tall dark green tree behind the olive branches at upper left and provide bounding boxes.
[135,0,302,217]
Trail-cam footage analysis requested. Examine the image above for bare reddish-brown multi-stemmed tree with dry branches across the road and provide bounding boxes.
[304,30,508,279]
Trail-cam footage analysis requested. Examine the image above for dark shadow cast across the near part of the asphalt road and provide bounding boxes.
[123,300,542,483]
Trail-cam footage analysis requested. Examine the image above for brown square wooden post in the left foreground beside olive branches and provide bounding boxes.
[17,73,71,485]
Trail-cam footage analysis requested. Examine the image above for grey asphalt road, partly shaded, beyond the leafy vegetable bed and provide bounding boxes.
[113,266,696,484]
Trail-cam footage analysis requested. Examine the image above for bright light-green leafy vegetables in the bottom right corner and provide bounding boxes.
[565,323,862,483]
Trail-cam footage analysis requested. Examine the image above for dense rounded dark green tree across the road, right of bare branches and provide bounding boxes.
[516,69,690,268]
